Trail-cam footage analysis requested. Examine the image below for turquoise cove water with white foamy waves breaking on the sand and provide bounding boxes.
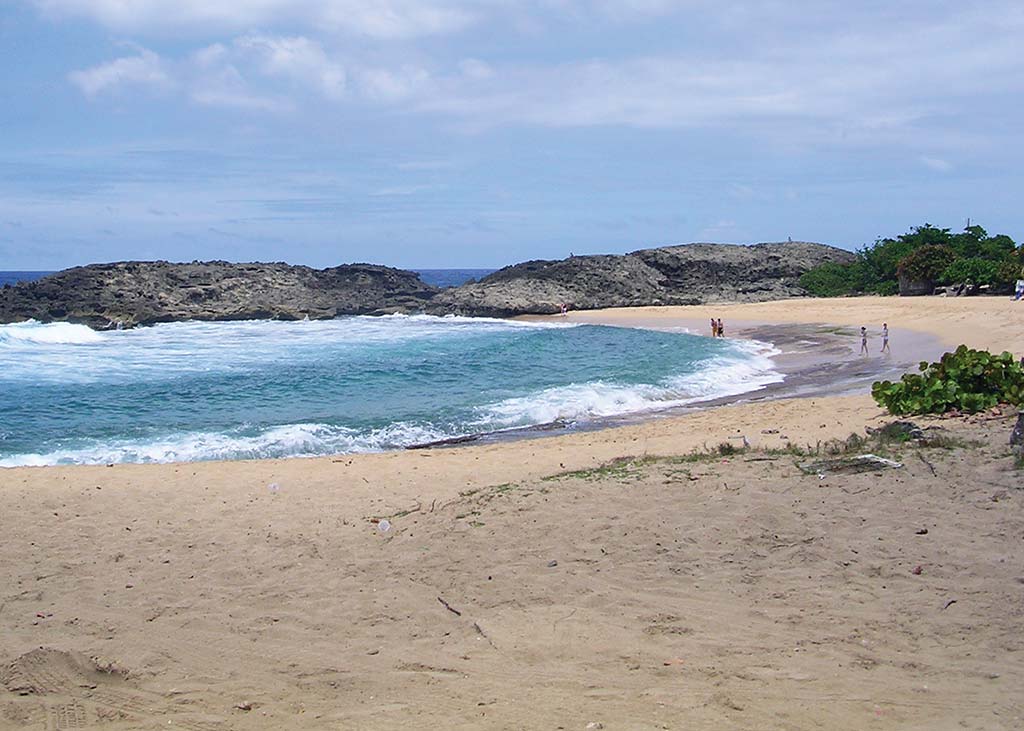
[0,315,781,467]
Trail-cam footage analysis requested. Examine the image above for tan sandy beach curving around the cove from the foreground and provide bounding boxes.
[0,297,1024,731]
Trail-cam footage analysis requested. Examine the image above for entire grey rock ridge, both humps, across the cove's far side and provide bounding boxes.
[0,242,853,329]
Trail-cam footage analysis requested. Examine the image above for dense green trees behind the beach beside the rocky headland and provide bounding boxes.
[800,223,1024,297]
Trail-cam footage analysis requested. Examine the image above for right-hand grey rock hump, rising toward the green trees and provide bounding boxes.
[428,242,854,317]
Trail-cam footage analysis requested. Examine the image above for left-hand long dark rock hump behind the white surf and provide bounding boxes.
[0,261,437,329]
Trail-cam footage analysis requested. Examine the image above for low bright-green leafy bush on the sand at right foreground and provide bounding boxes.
[871,345,1024,415]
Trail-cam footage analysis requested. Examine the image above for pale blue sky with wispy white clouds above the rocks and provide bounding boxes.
[0,0,1024,270]
